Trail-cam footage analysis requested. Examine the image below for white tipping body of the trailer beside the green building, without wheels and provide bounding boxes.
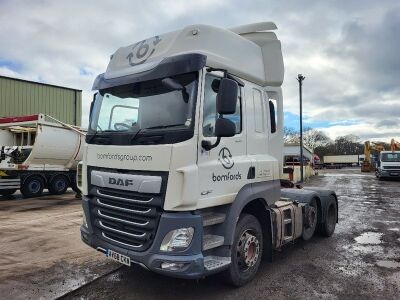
[0,114,85,171]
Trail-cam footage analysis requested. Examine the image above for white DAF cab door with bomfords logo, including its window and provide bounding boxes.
[198,72,251,208]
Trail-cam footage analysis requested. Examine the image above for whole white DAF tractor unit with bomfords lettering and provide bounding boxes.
[77,22,338,286]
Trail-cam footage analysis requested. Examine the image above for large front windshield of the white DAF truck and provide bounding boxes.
[88,73,198,134]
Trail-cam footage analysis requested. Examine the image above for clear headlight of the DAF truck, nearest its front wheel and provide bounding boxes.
[160,227,194,252]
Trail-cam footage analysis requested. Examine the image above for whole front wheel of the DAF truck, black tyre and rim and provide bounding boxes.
[222,214,263,287]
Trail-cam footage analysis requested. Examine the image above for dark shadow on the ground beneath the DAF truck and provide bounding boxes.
[90,236,327,299]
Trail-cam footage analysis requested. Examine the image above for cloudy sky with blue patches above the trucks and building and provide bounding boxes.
[0,0,400,141]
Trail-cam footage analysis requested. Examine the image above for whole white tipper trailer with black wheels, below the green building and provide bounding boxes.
[0,114,85,197]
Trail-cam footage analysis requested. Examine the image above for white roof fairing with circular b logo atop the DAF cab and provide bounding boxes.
[104,23,284,86]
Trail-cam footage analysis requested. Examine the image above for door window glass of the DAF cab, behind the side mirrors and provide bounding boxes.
[203,74,242,137]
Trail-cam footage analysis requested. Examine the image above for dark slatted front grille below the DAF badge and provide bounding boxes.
[88,168,166,251]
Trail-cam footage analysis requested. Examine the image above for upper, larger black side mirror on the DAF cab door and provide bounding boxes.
[217,78,238,115]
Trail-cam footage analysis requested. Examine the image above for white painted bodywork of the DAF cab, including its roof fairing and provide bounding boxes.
[82,23,283,211]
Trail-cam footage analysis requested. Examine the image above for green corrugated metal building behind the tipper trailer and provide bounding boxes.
[0,76,82,126]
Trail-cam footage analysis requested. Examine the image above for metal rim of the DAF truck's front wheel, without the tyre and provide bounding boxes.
[236,230,260,271]
